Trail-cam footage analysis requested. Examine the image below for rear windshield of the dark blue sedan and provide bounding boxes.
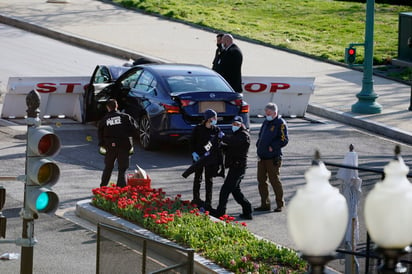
[166,75,233,94]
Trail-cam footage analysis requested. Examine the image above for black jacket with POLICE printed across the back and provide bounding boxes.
[98,110,138,147]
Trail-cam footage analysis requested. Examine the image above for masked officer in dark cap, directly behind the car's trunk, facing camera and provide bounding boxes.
[187,109,224,206]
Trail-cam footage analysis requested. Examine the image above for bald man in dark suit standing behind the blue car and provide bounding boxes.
[216,34,243,93]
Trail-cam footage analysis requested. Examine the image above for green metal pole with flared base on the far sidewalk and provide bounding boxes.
[352,0,382,114]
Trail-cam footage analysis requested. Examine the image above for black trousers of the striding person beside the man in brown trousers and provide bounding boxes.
[216,167,252,216]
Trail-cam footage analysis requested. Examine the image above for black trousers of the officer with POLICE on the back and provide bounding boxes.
[100,144,131,187]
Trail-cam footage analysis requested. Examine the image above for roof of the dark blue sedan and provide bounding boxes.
[138,64,217,76]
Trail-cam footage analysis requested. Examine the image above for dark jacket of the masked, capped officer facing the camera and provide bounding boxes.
[191,123,220,165]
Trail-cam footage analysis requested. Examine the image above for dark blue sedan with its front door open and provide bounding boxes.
[85,64,249,149]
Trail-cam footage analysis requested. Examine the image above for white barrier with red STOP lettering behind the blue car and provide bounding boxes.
[1,76,315,122]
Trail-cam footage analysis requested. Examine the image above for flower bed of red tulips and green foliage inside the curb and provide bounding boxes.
[92,186,307,273]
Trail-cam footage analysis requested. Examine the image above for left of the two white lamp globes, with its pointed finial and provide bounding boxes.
[287,152,348,274]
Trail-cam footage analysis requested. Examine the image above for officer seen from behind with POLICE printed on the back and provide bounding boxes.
[98,99,138,187]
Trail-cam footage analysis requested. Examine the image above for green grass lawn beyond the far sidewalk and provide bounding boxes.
[114,0,410,65]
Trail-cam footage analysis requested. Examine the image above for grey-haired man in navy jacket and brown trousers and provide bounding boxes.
[255,103,289,212]
